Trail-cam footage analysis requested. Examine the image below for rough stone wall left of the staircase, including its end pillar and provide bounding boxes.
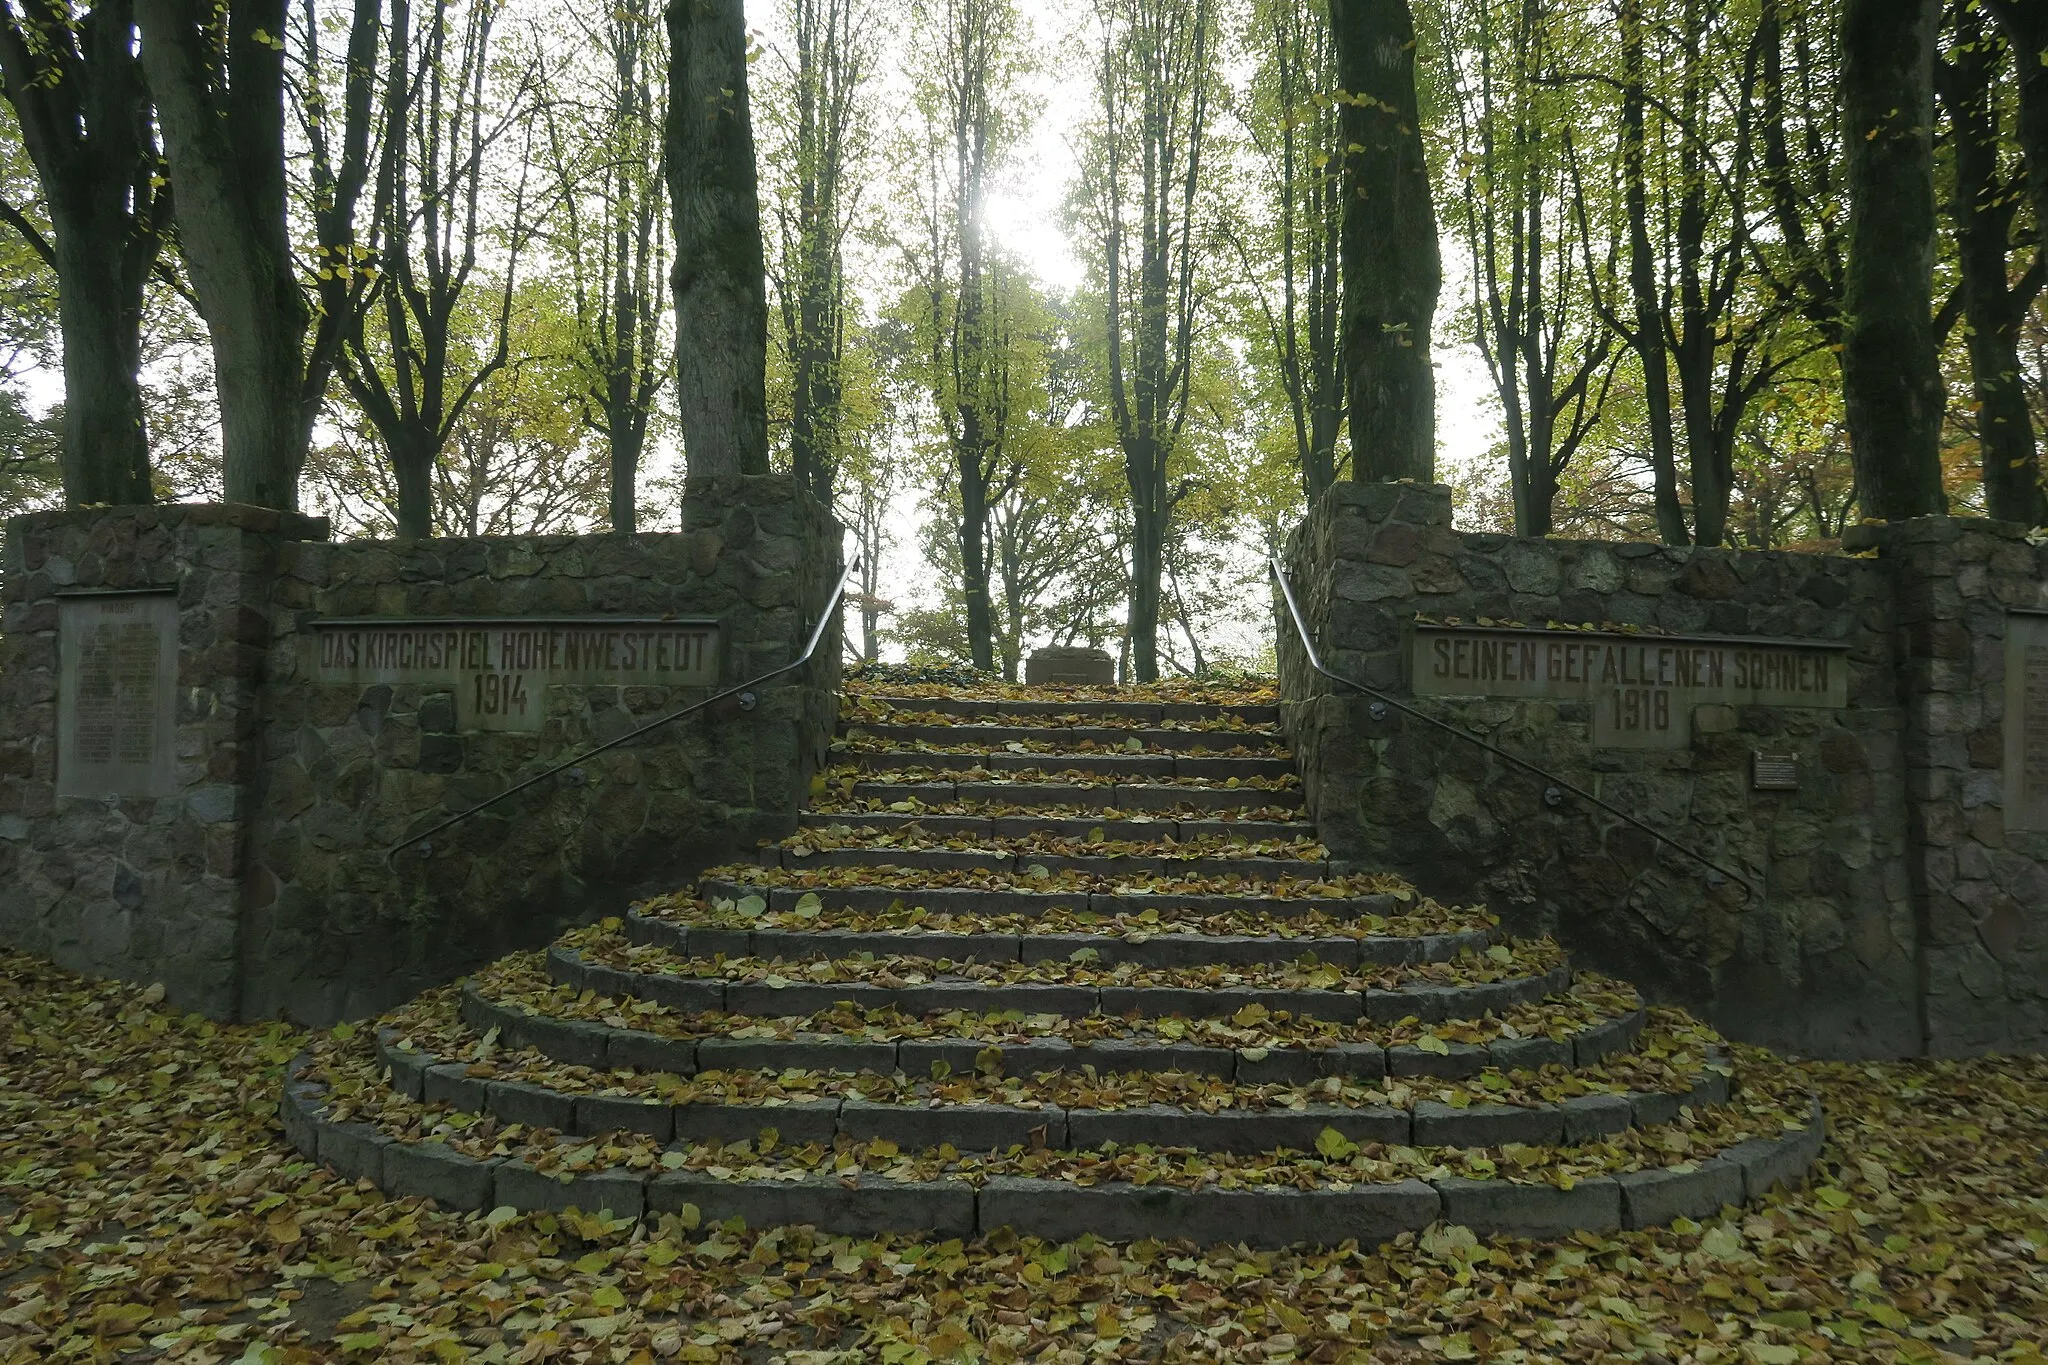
[0,477,840,1023]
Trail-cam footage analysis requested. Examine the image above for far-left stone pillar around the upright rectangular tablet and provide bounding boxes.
[0,505,328,1017]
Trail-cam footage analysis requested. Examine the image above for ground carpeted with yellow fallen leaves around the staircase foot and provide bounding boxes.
[0,956,2048,1365]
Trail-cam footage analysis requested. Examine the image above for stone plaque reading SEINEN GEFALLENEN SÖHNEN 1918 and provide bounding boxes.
[1409,626,1849,749]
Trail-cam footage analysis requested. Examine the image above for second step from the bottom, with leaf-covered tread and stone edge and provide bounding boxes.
[364,1009,1729,1154]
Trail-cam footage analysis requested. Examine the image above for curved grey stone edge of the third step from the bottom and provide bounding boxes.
[461,982,1645,1080]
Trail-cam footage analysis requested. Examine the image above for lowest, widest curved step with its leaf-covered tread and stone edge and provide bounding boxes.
[281,1042,1825,1244]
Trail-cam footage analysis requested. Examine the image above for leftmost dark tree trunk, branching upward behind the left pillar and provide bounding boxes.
[0,0,170,505]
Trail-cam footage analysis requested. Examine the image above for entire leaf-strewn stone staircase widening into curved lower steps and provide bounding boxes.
[283,686,1823,1244]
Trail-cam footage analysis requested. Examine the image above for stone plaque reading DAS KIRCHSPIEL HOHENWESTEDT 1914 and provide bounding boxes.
[305,616,719,731]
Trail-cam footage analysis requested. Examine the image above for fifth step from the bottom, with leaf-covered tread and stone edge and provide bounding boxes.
[623,896,1495,968]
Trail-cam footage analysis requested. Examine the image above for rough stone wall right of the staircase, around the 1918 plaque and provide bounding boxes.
[1280,485,2048,1056]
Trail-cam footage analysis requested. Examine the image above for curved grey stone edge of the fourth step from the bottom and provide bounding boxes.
[547,945,1571,1023]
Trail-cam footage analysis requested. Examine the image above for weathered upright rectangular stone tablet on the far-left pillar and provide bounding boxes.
[57,593,178,796]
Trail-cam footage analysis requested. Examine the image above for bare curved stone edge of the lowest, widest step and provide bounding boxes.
[279,1054,1827,1246]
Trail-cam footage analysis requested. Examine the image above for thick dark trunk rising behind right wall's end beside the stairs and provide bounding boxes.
[1329,0,1444,483]
